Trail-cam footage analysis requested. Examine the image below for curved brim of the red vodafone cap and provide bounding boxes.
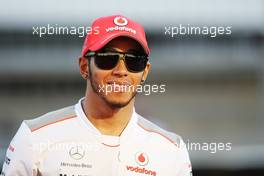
[85,32,150,55]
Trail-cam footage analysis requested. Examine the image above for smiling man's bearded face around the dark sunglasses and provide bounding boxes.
[82,37,150,108]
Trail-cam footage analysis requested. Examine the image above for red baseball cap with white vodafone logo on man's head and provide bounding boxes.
[82,15,150,56]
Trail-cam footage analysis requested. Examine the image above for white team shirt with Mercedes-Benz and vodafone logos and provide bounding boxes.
[1,99,191,176]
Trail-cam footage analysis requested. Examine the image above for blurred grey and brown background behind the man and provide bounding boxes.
[0,0,264,175]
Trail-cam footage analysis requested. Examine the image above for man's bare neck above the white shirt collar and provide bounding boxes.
[82,96,134,136]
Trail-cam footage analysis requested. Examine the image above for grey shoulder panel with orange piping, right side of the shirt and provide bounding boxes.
[137,115,183,147]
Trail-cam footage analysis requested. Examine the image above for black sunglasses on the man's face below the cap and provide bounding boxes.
[85,52,148,73]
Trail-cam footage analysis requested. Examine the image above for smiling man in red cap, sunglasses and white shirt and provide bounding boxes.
[2,15,191,176]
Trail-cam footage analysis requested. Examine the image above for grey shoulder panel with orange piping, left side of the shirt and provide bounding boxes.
[24,105,76,132]
